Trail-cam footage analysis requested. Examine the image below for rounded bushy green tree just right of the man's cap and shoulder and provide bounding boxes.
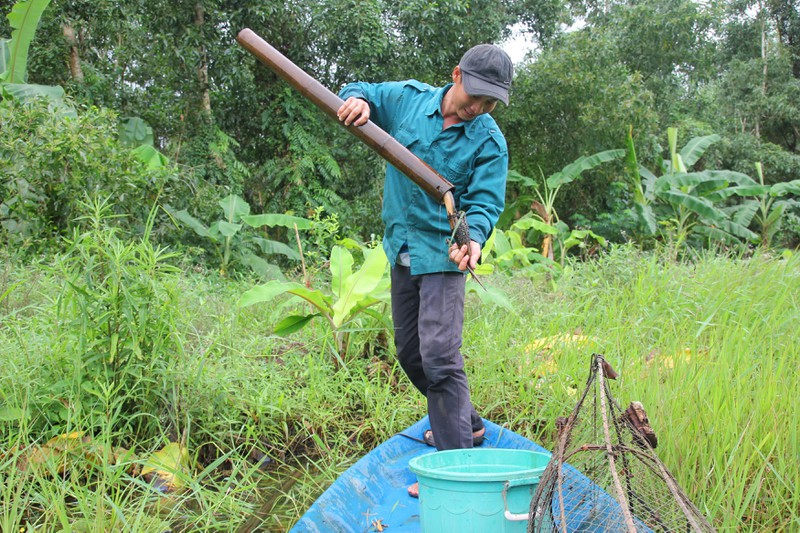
[497,28,656,224]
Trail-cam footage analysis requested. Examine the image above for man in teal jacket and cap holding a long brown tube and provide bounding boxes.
[338,44,513,497]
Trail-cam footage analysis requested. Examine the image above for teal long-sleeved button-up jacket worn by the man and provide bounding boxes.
[339,80,508,275]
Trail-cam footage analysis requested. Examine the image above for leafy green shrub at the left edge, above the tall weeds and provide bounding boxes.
[0,101,170,247]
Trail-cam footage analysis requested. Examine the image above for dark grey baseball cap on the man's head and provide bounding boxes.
[458,44,514,105]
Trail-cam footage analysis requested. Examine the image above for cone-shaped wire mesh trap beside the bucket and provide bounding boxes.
[528,354,714,533]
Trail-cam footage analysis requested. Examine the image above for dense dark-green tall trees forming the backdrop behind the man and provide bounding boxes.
[0,0,800,251]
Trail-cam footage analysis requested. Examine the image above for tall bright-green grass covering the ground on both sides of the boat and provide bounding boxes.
[0,243,800,532]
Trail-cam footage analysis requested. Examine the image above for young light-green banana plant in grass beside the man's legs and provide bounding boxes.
[239,245,390,361]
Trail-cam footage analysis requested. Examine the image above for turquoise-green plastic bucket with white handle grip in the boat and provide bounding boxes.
[408,448,550,533]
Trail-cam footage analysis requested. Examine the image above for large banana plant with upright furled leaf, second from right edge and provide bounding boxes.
[626,128,757,252]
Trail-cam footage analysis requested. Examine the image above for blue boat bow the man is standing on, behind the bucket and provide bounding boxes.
[290,417,549,533]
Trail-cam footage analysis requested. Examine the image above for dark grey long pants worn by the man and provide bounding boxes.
[392,265,483,450]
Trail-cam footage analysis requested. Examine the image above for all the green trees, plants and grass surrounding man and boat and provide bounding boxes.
[0,0,800,531]
